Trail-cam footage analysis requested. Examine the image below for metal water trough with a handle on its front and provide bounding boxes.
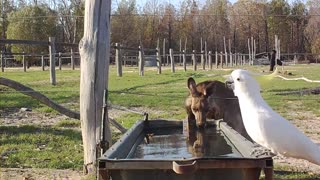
[98,120,273,180]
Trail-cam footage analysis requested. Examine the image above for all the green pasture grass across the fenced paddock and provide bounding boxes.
[0,65,320,179]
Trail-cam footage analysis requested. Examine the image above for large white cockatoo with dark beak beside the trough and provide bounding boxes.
[226,69,320,165]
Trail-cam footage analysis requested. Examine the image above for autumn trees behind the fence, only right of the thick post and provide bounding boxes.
[112,0,320,53]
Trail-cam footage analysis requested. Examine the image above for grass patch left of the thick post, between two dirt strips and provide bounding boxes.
[0,125,83,169]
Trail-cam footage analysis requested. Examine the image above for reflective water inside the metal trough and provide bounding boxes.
[130,127,242,160]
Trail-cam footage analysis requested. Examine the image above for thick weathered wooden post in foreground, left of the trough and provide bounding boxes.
[79,0,111,175]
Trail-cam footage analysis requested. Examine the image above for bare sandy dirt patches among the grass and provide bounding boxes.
[0,105,320,180]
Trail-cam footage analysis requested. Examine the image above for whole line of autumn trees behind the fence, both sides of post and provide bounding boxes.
[0,0,320,60]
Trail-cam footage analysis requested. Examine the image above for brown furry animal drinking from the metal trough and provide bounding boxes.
[185,78,251,139]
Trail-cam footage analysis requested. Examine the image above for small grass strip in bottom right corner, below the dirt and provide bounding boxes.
[274,170,320,180]
